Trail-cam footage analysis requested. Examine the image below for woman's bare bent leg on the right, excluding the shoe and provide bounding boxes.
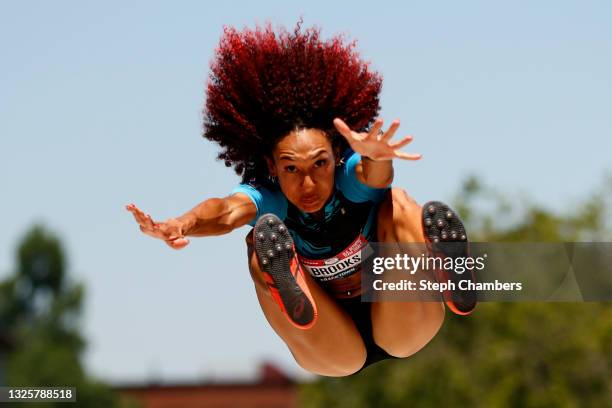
[372,189,445,357]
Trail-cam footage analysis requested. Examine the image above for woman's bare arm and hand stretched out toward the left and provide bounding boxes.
[126,193,257,249]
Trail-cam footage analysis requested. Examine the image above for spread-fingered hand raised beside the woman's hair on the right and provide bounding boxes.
[334,118,422,161]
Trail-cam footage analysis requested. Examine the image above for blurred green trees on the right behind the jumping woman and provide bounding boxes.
[301,178,612,408]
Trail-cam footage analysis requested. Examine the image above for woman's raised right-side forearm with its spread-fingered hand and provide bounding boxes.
[334,119,421,188]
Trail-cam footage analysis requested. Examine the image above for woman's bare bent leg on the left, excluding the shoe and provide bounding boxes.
[246,231,366,377]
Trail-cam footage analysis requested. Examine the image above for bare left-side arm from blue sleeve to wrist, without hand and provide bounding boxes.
[177,196,257,237]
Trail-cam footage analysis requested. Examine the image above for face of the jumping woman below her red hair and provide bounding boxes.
[267,129,336,213]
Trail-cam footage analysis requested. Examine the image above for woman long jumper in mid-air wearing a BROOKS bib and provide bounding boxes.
[127,24,476,376]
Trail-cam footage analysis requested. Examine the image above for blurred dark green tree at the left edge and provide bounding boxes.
[0,226,139,408]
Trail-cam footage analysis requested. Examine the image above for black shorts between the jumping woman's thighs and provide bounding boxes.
[336,296,398,374]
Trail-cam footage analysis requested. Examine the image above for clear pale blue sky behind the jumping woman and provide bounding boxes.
[0,0,612,382]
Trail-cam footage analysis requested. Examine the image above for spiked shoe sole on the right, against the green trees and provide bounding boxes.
[422,201,478,315]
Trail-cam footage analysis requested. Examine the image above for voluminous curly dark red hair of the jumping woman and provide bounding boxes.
[204,21,382,179]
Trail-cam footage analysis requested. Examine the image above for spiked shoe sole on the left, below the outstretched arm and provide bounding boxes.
[253,214,316,329]
